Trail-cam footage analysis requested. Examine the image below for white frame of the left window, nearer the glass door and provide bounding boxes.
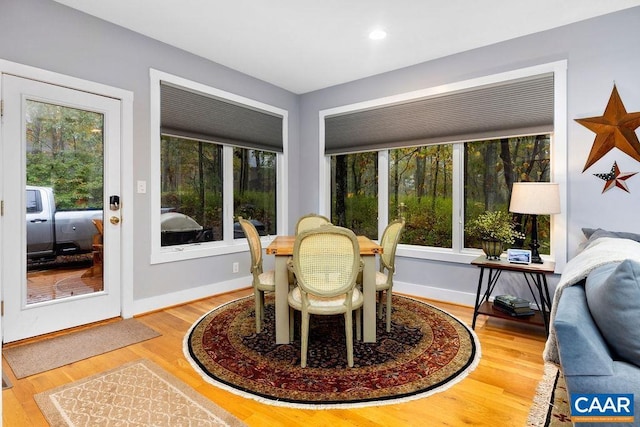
[148,69,289,264]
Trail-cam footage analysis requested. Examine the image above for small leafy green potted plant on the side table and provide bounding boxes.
[465,211,524,259]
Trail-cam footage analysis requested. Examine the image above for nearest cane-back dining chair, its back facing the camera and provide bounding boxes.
[288,225,364,368]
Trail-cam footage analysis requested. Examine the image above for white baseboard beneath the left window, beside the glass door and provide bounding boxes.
[132,276,251,316]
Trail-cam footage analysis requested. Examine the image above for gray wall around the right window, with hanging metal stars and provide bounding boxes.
[299,7,640,302]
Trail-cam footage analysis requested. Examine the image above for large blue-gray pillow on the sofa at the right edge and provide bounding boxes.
[585,260,640,366]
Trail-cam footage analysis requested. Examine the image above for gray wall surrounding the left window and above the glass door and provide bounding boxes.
[0,0,300,308]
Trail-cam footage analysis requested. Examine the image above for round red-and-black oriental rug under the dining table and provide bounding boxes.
[184,295,480,409]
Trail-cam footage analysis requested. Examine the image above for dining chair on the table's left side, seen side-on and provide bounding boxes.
[238,217,276,333]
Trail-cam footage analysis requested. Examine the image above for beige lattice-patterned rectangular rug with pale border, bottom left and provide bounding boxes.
[34,360,245,427]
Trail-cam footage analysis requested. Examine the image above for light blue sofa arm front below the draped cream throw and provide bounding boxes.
[553,285,614,376]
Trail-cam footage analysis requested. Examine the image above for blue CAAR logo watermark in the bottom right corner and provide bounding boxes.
[571,393,635,423]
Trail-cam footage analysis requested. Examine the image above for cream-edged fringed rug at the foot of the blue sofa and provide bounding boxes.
[527,364,573,427]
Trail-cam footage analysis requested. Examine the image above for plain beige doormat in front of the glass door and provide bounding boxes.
[2,319,160,378]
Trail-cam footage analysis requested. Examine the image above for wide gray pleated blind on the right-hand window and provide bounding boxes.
[325,73,554,154]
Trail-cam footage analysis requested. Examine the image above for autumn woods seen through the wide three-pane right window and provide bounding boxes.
[331,134,551,254]
